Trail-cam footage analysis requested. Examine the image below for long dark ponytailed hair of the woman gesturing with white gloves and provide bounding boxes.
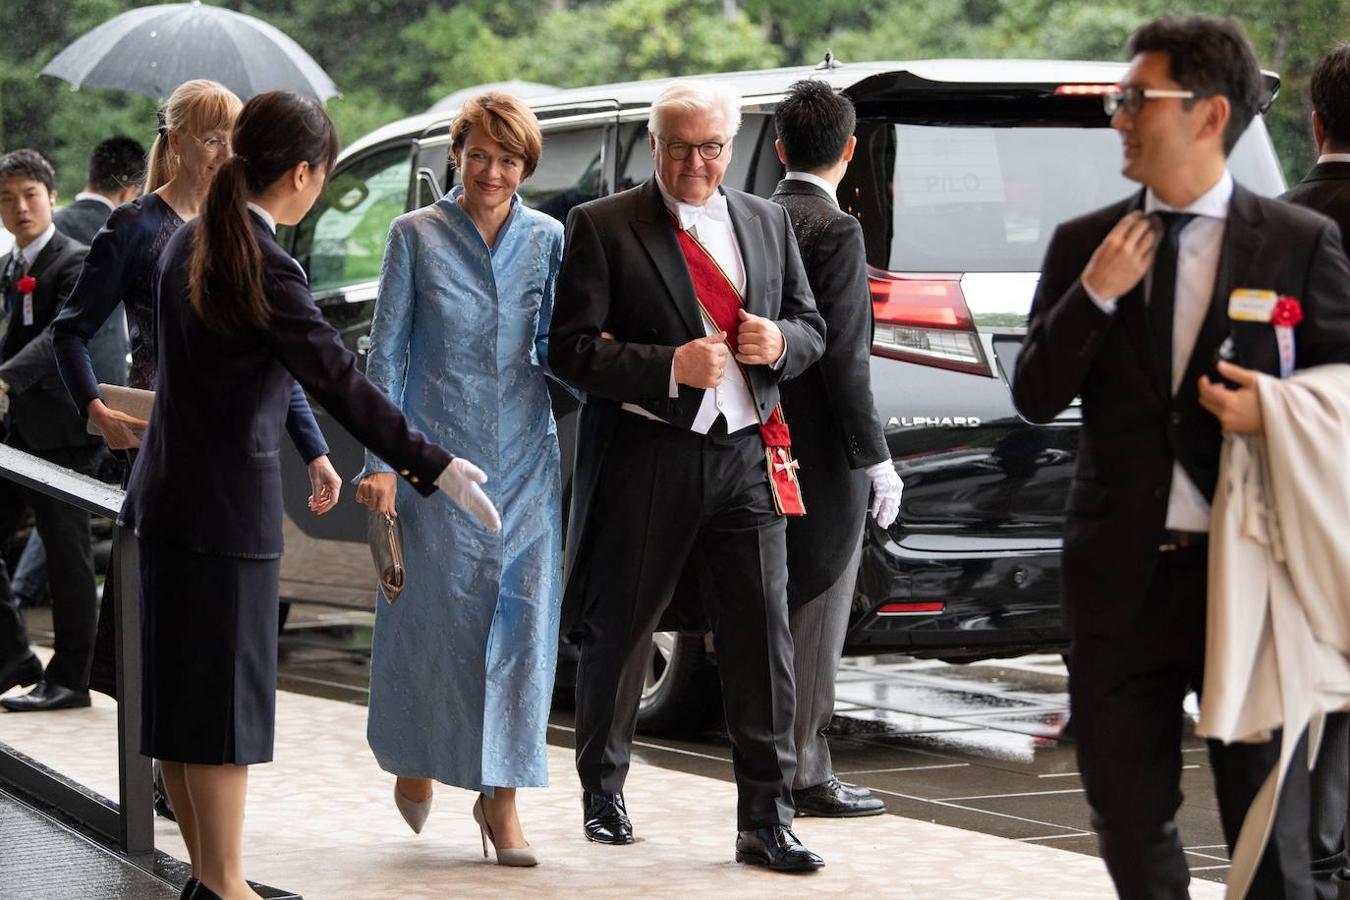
[189,90,338,335]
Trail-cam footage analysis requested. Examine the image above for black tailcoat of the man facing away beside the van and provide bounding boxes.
[772,179,890,606]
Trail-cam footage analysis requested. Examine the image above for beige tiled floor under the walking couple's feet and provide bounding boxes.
[0,666,1222,900]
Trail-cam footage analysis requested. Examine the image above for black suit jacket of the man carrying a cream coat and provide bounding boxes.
[1013,185,1350,634]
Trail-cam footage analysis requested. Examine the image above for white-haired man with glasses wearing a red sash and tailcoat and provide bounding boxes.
[548,81,825,872]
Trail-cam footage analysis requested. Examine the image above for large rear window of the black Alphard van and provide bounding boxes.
[840,117,1284,273]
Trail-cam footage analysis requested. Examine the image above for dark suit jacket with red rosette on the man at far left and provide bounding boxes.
[0,231,100,455]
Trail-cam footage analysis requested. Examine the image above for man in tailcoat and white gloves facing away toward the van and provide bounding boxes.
[772,80,903,818]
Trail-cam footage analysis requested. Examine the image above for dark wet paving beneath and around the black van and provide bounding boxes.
[18,604,1227,881]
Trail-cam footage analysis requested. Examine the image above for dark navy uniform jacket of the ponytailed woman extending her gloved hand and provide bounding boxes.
[122,217,452,559]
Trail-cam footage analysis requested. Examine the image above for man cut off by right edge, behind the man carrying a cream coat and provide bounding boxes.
[1281,43,1350,900]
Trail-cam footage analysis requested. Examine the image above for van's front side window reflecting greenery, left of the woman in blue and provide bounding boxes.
[294,144,412,293]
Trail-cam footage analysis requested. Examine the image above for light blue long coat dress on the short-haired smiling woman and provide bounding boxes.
[362,188,563,796]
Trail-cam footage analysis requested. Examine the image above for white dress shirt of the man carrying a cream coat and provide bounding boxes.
[1084,169,1233,532]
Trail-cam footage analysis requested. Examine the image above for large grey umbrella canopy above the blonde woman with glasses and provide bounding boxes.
[38,3,338,101]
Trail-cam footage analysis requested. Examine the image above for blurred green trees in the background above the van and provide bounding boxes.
[0,0,1350,196]
